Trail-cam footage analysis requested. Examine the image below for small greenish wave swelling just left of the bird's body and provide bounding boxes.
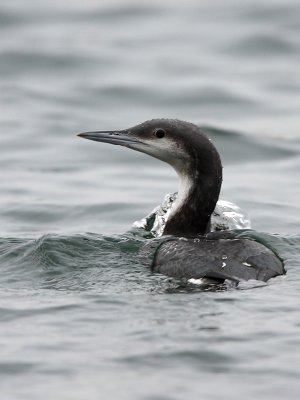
[0,234,150,292]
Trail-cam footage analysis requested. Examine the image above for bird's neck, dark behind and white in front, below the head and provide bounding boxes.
[163,154,222,237]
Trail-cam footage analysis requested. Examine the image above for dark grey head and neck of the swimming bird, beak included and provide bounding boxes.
[78,119,222,236]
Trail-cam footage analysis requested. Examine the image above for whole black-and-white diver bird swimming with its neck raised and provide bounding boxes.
[78,119,284,282]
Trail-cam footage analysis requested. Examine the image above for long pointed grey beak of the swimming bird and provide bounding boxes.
[77,131,140,147]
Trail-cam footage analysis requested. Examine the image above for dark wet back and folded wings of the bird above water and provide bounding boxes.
[152,237,284,281]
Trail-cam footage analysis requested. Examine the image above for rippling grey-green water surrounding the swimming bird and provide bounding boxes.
[0,0,300,400]
